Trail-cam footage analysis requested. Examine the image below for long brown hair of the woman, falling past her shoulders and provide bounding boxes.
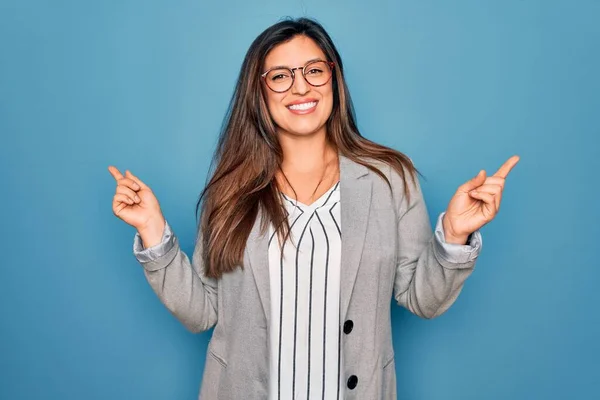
[196,18,418,278]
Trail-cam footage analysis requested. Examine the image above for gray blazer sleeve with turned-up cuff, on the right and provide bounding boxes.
[391,163,482,318]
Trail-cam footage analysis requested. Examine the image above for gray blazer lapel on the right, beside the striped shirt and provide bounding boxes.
[340,155,372,321]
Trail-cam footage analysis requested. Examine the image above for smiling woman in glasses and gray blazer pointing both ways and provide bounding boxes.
[109,18,518,400]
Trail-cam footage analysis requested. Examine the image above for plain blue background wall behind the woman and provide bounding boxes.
[0,0,600,400]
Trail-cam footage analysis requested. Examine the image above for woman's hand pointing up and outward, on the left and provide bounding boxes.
[108,165,165,239]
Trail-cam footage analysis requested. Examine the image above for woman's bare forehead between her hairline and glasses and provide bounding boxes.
[264,36,326,69]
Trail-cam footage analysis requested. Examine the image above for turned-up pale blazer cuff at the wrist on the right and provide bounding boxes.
[433,211,483,264]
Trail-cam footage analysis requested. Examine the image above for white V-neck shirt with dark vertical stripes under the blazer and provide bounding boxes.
[269,182,344,400]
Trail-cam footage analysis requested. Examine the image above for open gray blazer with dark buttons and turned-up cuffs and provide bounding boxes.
[134,155,482,400]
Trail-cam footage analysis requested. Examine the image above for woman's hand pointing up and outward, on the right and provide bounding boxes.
[442,156,519,244]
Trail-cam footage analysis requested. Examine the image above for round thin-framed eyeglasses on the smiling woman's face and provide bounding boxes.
[260,60,335,93]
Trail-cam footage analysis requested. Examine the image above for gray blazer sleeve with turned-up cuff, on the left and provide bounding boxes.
[133,221,218,333]
